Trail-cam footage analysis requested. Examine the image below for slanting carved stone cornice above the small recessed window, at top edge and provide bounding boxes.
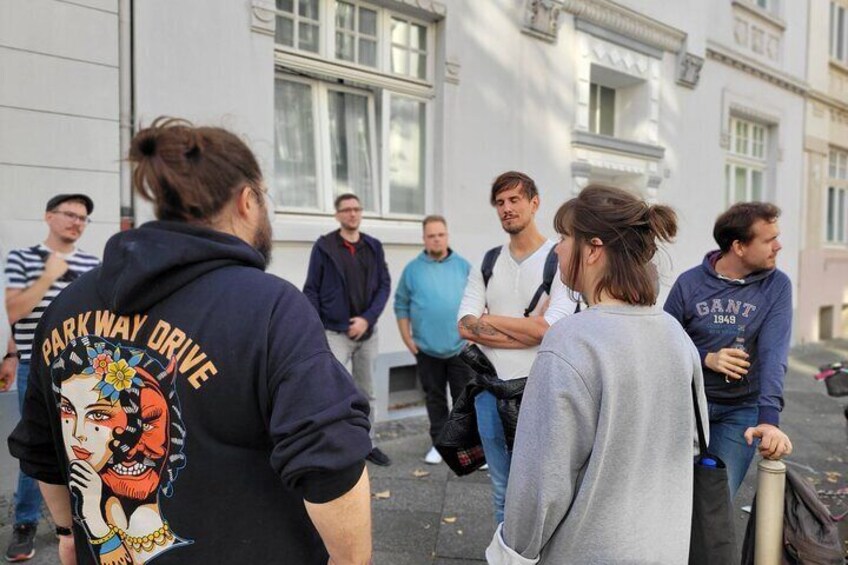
[556,0,686,53]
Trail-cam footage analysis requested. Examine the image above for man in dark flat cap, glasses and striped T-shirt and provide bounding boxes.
[0,194,100,562]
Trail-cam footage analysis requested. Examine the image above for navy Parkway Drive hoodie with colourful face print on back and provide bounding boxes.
[9,222,371,565]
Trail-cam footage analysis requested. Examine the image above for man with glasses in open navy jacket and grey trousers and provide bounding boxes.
[303,193,391,466]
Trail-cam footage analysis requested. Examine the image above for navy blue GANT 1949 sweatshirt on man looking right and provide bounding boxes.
[665,250,792,426]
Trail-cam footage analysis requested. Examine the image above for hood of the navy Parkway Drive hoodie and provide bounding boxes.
[97,222,266,315]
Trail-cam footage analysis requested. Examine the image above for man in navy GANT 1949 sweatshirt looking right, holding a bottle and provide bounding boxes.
[665,202,792,497]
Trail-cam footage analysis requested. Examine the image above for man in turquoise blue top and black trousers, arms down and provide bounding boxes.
[395,216,472,465]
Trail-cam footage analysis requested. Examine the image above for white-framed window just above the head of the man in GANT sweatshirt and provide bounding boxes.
[724,118,768,204]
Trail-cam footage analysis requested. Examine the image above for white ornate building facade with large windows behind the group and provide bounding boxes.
[0,0,820,419]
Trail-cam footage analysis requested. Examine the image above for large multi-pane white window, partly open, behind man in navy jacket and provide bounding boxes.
[273,0,435,217]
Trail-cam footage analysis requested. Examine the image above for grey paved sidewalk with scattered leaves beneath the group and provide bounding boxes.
[0,340,848,565]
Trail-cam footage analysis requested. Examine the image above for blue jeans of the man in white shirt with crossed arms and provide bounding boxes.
[474,391,512,524]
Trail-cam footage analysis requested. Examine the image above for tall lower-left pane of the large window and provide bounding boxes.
[274,80,318,208]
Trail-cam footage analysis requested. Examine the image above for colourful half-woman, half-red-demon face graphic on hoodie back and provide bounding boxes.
[52,336,190,563]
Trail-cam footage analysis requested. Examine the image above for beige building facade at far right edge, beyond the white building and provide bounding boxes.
[797,0,848,341]
